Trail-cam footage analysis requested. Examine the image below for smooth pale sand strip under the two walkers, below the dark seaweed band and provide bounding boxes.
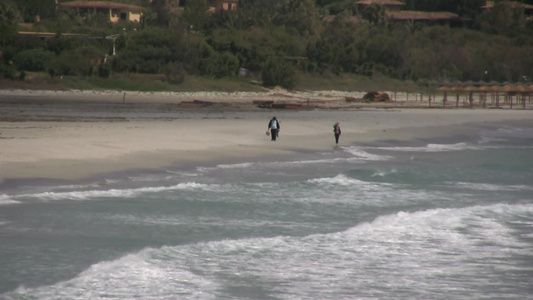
[0,92,533,182]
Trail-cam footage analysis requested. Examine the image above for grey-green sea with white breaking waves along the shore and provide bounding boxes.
[0,122,533,300]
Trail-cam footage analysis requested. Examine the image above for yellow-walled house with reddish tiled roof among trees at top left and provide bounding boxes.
[59,1,144,23]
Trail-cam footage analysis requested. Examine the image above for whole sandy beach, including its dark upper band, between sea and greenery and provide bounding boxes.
[0,91,533,183]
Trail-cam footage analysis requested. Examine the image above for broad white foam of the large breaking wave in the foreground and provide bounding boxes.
[7,204,533,299]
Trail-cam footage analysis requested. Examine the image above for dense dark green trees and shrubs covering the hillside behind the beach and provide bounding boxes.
[0,0,533,88]
